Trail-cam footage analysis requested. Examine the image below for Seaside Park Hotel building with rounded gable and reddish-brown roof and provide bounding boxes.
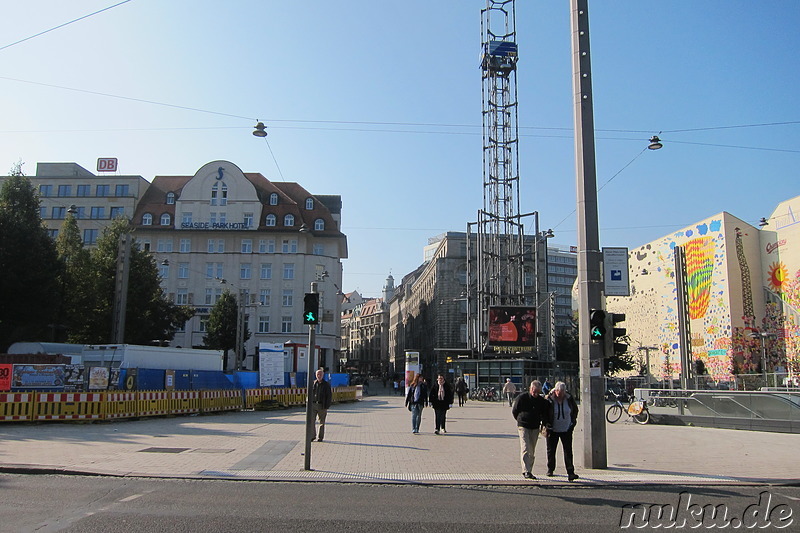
[133,161,347,368]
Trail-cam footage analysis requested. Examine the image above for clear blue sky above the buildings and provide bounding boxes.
[0,0,800,296]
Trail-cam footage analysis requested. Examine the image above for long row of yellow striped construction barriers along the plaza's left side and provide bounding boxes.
[0,387,357,422]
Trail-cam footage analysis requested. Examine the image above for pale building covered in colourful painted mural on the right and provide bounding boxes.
[607,193,800,384]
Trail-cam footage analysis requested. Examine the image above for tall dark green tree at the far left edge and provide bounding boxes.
[0,163,61,352]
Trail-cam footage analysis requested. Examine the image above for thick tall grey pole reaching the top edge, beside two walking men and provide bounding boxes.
[570,0,608,468]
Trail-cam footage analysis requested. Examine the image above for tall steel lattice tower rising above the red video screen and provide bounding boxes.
[467,0,526,353]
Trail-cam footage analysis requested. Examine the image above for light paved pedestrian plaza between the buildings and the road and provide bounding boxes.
[0,395,800,485]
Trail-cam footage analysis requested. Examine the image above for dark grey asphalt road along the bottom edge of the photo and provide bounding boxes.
[0,474,800,533]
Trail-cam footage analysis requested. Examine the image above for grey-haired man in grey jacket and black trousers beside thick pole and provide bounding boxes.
[547,381,578,481]
